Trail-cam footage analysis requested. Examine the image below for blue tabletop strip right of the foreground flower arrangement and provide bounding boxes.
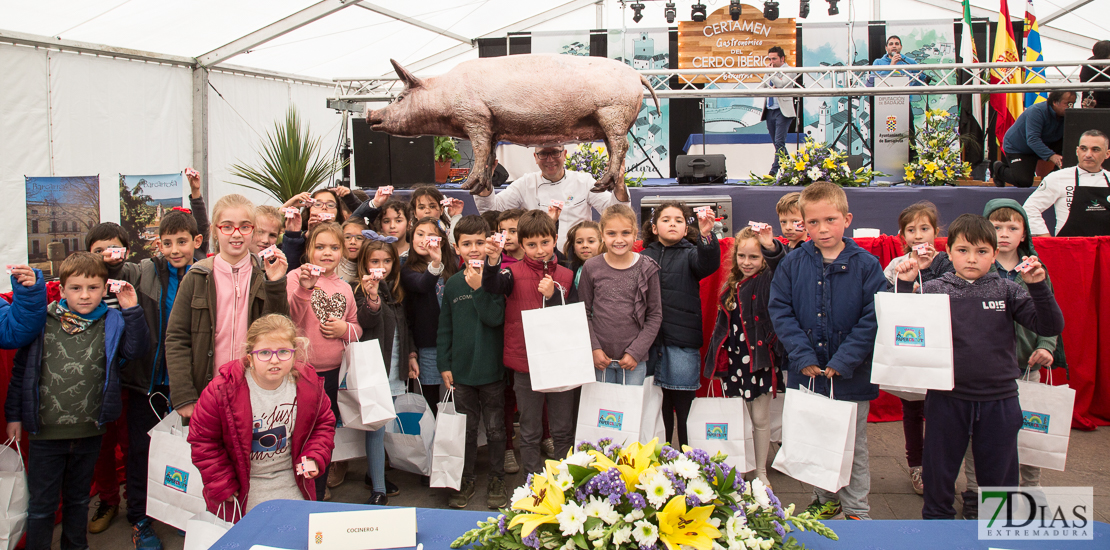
[790,520,1110,550]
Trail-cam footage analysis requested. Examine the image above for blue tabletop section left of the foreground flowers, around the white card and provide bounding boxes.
[211,500,497,550]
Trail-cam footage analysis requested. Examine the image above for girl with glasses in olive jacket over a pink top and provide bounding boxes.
[165,194,289,418]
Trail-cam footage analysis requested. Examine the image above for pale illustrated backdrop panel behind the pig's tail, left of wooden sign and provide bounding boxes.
[607,29,670,178]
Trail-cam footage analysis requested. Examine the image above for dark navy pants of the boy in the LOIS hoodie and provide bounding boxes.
[921,391,1021,519]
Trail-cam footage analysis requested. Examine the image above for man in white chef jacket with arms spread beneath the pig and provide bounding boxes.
[474,146,632,250]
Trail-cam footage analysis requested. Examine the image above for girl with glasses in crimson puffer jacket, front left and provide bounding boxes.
[189,314,335,522]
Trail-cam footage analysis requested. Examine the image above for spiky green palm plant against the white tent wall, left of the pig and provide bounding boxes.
[231,106,347,203]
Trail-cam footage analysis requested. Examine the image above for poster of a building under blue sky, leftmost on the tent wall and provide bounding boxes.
[26,176,100,271]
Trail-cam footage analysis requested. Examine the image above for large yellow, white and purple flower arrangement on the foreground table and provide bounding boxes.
[451,439,837,550]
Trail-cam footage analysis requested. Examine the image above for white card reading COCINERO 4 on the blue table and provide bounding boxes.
[309,508,416,550]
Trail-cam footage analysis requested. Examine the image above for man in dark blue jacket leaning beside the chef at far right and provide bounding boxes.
[990,91,1076,187]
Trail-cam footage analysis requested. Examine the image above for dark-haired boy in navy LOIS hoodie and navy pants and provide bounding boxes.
[897,214,1063,519]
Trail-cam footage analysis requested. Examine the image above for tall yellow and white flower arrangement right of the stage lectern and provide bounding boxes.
[906,109,971,186]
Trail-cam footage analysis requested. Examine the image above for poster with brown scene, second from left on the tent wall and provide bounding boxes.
[120,172,184,260]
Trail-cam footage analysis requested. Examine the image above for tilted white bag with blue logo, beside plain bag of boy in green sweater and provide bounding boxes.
[385,392,435,476]
